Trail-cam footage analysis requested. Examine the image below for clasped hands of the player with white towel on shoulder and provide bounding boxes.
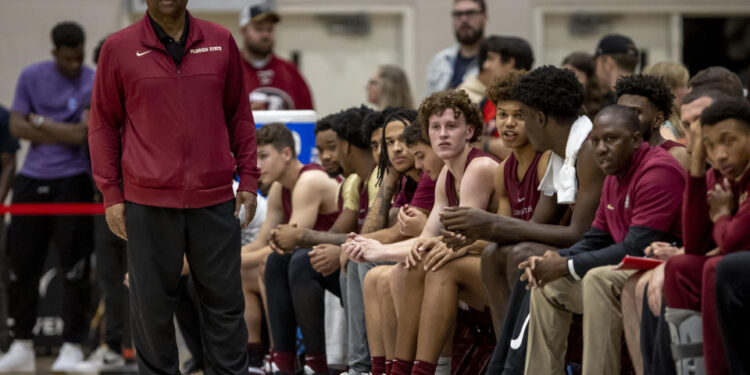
[440,207,500,243]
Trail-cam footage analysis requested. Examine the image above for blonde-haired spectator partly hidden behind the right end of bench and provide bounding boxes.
[643,61,690,140]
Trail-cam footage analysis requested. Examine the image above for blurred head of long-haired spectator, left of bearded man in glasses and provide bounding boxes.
[367,65,414,111]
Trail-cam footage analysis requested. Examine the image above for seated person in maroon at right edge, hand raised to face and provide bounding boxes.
[664,98,750,375]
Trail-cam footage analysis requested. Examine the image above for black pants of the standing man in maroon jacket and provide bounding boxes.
[125,200,247,375]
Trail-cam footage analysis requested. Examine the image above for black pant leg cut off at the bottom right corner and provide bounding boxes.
[716,251,750,375]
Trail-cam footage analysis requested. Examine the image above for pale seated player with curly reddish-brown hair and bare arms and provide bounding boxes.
[348,90,498,374]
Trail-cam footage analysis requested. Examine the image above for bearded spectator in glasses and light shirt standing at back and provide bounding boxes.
[427,0,487,95]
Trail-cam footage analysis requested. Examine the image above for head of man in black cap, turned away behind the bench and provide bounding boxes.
[594,34,639,90]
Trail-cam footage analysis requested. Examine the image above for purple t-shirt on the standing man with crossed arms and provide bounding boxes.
[11,61,94,179]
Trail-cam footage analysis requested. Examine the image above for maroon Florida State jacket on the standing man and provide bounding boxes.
[89,14,259,208]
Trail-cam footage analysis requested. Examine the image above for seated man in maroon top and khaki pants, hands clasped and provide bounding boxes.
[519,105,686,375]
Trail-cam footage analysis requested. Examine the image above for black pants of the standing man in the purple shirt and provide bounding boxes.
[8,174,94,343]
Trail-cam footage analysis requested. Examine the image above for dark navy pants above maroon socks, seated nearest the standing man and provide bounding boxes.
[265,249,341,355]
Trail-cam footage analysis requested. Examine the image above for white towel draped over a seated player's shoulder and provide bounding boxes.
[539,116,593,204]
